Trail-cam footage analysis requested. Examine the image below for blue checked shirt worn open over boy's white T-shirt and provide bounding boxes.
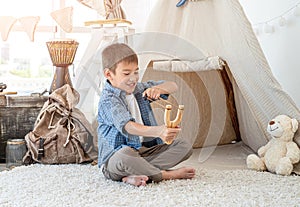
[98,80,168,167]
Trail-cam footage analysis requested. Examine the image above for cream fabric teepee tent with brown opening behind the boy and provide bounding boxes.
[75,0,300,170]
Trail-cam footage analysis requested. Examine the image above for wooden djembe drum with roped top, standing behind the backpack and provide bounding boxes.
[46,39,78,93]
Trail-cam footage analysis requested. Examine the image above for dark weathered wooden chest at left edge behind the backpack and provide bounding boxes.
[0,96,48,162]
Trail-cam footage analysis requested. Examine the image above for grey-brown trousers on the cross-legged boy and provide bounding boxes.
[102,139,192,182]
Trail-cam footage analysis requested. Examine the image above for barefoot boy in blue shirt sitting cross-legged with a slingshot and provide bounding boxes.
[98,43,195,186]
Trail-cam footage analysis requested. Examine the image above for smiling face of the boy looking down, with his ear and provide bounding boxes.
[104,62,139,94]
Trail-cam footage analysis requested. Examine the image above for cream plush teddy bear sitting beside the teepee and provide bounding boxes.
[246,115,300,175]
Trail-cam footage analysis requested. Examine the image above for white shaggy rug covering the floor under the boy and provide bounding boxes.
[0,164,300,207]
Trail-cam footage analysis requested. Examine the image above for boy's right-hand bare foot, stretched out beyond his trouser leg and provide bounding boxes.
[162,167,196,180]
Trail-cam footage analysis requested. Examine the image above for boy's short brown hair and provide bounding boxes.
[102,43,138,73]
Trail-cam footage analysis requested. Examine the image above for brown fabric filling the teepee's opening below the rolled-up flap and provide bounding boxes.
[142,62,239,148]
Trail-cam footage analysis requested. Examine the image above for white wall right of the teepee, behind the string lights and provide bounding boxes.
[240,0,300,108]
